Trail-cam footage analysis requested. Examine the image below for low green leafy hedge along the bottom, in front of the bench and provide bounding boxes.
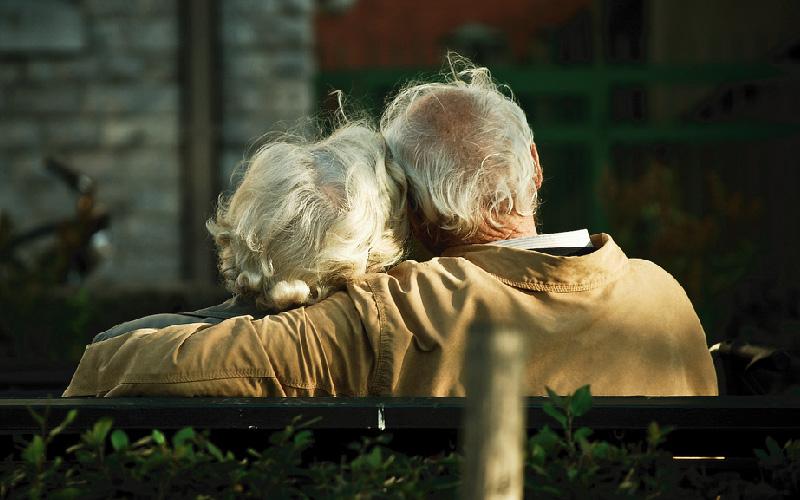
[0,387,800,499]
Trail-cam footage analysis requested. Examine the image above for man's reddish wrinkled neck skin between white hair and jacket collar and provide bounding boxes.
[409,212,537,255]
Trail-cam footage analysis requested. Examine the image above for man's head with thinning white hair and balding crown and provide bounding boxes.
[381,55,542,248]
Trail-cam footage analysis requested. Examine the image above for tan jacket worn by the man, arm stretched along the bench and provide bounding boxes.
[64,235,717,396]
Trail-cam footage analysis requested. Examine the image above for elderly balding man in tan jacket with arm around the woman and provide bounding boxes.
[65,58,717,396]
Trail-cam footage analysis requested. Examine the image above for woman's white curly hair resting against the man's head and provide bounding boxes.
[206,122,408,311]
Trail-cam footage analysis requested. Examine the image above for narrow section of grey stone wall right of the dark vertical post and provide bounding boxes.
[220,0,314,186]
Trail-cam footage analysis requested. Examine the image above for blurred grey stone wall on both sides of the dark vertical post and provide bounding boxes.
[0,0,313,288]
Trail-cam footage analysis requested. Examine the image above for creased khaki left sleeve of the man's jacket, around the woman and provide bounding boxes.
[64,293,374,397]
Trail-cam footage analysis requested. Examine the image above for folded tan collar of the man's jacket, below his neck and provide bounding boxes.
[442,233,628,292]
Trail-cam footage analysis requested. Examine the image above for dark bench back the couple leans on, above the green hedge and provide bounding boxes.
[0,396,800,458]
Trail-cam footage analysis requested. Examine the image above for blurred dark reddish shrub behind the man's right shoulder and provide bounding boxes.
[602,162,762,336]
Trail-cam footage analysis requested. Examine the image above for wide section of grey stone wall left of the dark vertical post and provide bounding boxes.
[0,0,180,285]
